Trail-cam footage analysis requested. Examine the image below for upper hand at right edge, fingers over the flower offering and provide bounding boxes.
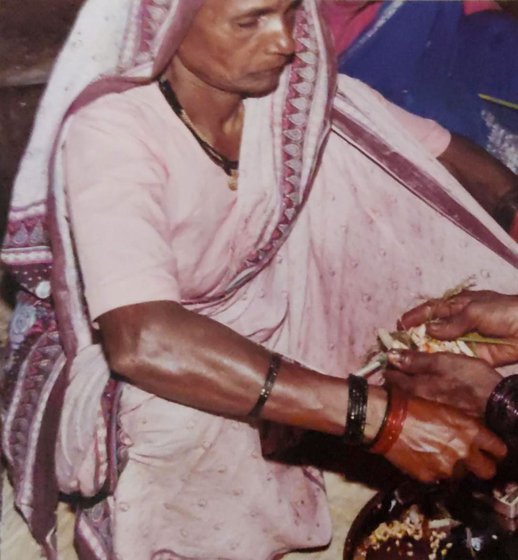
[400,290,518,366]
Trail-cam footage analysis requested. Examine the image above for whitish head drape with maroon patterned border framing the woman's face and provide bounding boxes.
[2,0,333,558]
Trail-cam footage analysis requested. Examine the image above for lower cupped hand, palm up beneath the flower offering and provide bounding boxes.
[384,350,502,418]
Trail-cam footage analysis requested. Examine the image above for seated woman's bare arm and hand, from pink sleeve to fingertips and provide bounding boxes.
[95,302,506,481]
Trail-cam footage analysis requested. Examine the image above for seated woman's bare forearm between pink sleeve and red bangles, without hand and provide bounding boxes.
[99,302,385,436]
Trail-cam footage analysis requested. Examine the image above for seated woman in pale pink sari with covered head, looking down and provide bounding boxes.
[3,0,518,560]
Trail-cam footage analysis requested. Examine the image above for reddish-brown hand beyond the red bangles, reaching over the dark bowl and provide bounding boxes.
[385,398,507,483]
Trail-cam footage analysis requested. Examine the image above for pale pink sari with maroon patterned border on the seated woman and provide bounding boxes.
[3,0,518,559]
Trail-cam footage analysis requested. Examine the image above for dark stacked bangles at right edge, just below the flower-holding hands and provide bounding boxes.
[486,375,518,442]
